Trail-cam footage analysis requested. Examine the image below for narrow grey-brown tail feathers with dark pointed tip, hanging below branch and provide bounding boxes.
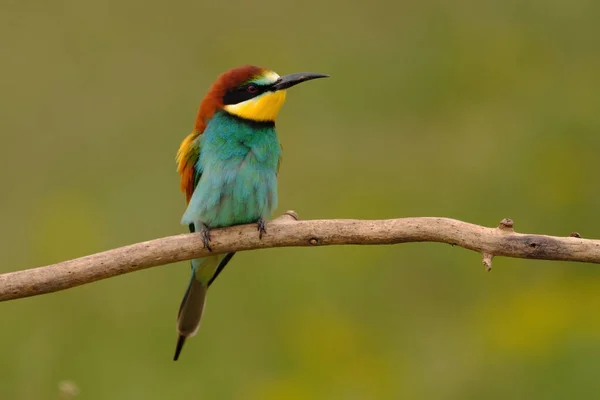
[173,269,208,361]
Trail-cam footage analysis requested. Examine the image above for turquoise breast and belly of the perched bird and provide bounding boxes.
[181,111,281,228]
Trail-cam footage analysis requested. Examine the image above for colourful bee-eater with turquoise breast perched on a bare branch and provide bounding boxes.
[173,65,329,361]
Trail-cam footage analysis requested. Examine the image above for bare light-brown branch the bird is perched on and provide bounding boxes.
[0,211,600,301]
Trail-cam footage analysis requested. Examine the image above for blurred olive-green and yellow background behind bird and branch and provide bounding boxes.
[0,0,600,400]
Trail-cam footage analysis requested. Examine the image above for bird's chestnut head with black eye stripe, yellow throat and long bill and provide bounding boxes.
[196,65,329,132]
